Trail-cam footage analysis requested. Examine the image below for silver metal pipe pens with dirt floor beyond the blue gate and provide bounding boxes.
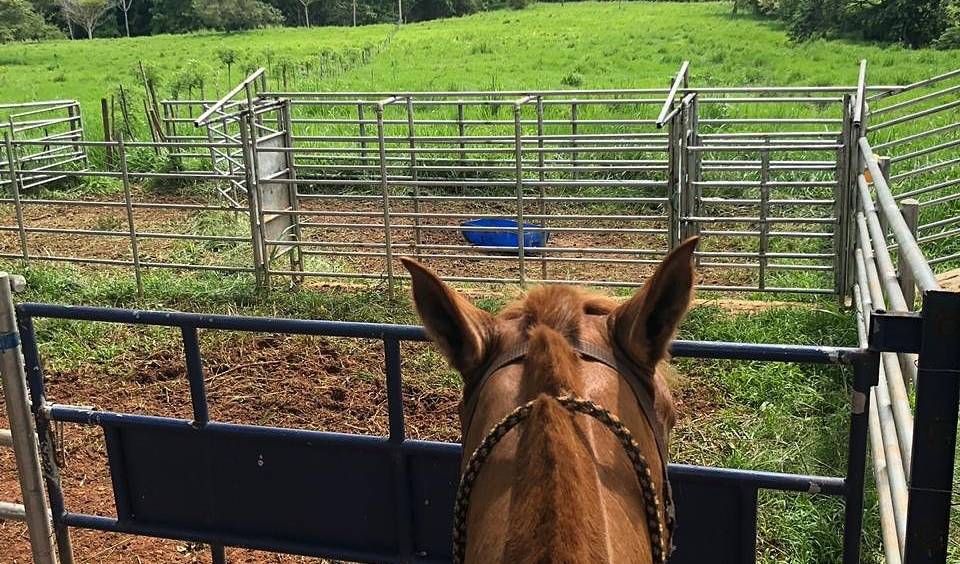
[0,65,958,294]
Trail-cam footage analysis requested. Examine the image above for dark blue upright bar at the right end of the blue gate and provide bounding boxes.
[843,351,880,564]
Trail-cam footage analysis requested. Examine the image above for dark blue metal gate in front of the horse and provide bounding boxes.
[17,304,902,564]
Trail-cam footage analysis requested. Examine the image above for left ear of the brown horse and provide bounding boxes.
[400,258,494,377]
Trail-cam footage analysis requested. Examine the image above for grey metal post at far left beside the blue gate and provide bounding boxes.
[0,274,56,564]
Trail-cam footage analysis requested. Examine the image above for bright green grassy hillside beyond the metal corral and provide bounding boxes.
[0,2,957,110]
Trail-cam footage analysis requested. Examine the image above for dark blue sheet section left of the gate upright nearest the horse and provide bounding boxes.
[107,428,398,554]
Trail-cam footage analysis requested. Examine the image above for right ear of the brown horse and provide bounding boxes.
[610,237,698,370]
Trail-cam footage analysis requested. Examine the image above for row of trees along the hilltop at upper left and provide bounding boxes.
[0,0,535,43]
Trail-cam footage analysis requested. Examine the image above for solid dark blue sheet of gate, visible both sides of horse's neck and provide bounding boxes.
[94,417,756,564]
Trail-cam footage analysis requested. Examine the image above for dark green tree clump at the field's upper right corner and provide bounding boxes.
[733,0,960,49]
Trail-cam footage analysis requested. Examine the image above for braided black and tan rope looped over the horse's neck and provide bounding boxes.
[453,395,673,564]
